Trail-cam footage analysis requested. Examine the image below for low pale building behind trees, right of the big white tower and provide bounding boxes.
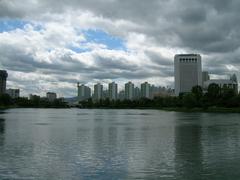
[203,74,238,94]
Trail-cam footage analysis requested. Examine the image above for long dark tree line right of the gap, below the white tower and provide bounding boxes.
[79,84,240,113]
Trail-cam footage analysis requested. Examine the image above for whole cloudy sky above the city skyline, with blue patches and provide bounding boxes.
[0,0,240,97]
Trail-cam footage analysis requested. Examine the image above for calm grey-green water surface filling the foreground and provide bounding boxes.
[0,109,240,180]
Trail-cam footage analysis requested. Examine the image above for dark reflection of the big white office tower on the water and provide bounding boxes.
[175,113,203,179]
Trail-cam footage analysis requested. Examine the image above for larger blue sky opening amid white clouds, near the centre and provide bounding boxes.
[83,29,127,51]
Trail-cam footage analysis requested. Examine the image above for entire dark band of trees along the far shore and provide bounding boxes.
[0,84,240,113]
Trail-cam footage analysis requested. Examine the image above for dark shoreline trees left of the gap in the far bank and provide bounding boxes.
[0,94,69,109]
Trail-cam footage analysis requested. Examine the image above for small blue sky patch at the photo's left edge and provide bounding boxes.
[0,19,30,33]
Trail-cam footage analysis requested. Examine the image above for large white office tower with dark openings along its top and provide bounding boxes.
[174,54,202,96]
